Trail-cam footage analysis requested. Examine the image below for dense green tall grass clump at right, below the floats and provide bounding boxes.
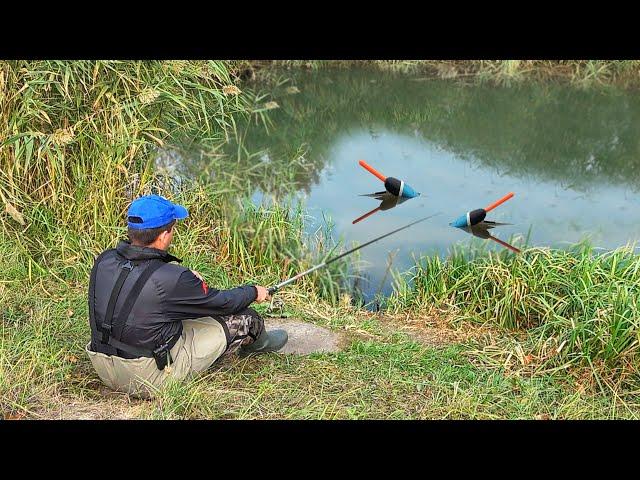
[388,244,640,375]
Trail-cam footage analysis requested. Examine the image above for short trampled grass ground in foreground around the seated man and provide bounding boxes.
[0,256,640,419]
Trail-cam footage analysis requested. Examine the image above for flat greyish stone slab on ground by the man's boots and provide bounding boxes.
[265,318,347,355]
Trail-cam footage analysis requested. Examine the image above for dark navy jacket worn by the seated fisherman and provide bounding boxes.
[89,241,258,358]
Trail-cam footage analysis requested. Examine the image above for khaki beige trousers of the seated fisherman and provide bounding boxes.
[85,317,227,398]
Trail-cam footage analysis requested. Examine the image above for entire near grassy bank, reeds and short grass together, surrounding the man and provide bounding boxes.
[0,61,640,418]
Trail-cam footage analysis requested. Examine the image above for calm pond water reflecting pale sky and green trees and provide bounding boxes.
[202,69,640,299]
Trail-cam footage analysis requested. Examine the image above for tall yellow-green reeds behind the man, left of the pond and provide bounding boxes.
[0,61,356,299]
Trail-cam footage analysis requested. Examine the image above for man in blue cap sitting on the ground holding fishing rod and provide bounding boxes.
[85,195,288,396]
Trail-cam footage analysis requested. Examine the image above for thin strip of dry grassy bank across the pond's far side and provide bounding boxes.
[254,60,640,88]
